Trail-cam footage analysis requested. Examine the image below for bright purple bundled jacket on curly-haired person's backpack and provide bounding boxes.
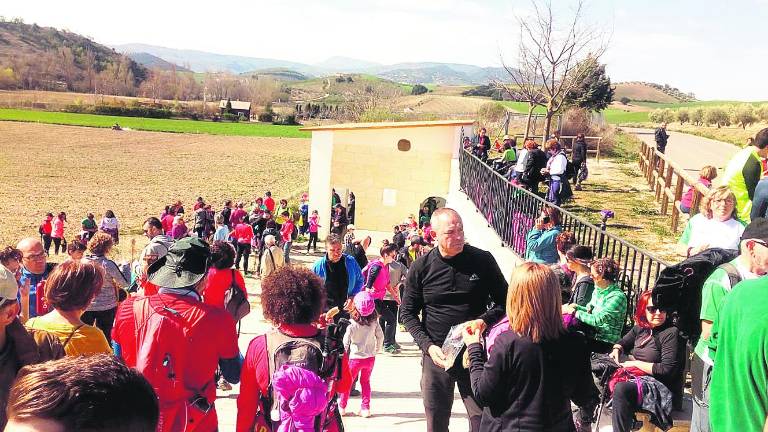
[272,365,328,432]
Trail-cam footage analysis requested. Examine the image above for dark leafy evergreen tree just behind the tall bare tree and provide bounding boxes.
[565,57,614,111]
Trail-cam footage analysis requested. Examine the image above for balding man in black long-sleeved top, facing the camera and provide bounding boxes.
[400,208,507,432]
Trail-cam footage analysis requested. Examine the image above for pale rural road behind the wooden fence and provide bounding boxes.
[622,128,739,176]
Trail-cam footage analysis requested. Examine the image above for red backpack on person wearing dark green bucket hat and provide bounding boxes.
[133,296,211,432]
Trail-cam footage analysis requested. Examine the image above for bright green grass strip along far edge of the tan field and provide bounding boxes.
[0,109,311,138]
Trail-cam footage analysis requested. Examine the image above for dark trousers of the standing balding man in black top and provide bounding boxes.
[421,354,483,432]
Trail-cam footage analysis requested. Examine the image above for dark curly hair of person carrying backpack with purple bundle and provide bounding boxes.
[261,267,325,324]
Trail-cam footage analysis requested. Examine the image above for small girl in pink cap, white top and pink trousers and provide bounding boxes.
[339,291,384,417]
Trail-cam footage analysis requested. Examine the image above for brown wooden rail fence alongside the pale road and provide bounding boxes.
[640,142,709,231]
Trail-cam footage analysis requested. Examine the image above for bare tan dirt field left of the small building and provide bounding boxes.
[0,122,310,258]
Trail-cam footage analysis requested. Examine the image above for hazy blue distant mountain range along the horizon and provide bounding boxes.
[114,44,510,85]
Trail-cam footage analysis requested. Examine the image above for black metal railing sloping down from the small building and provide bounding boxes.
[459,151,668,311]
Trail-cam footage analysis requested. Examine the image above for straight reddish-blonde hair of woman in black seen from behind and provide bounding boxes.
[507,262,565,343]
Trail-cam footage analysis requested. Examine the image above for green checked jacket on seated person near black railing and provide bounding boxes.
[576,284,627,343]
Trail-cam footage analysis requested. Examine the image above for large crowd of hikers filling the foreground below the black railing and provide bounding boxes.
[0,126,768,432]
